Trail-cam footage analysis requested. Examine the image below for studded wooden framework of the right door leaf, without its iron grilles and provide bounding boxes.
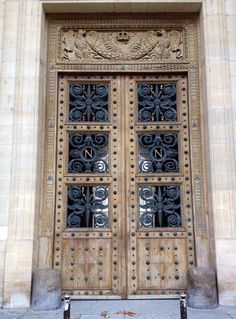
[125,75,195,295]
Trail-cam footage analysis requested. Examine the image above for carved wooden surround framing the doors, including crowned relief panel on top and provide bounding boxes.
[39,14,208,266]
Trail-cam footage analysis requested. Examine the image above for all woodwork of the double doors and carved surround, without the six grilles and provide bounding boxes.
[39,15,208,299]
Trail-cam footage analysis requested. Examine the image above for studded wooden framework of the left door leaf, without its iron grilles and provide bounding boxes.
[54,75,125,296]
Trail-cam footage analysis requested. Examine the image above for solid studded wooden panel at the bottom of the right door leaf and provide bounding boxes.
[137,238,187,291]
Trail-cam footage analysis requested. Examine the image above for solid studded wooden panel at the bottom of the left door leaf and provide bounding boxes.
[62,238,112,290]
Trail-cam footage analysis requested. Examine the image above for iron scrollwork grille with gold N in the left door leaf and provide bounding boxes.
[68,133,109,173]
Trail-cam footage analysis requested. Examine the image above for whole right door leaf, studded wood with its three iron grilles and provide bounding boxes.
[125,74,195,298]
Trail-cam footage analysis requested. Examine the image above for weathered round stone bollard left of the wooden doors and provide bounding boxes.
[31,268,61,311]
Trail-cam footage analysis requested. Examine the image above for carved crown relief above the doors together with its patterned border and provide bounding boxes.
[49,14,200,65]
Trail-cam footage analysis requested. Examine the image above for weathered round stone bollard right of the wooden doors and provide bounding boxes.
[188,267,217,309]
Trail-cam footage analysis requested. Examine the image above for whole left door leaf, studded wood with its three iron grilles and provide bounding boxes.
[54,75,126,298]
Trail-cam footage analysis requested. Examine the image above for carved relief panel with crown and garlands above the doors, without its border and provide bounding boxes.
[61,29,183,62]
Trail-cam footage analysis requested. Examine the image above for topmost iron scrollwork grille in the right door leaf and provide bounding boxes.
[138,83,177,122]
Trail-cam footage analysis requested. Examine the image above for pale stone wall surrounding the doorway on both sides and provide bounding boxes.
[0,0,236,307]
